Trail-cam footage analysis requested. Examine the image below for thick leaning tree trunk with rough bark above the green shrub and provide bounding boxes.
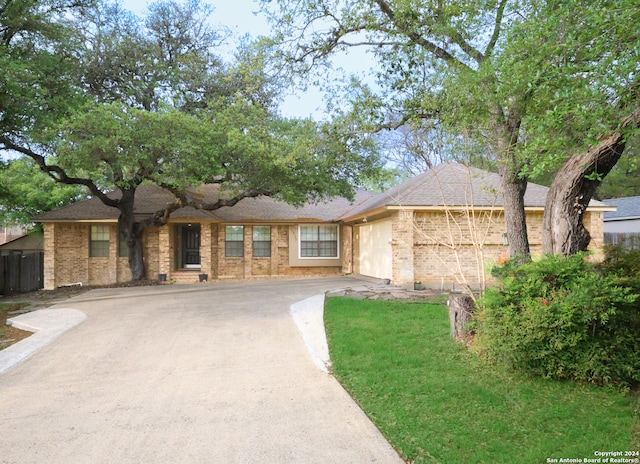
[542,108,640,256]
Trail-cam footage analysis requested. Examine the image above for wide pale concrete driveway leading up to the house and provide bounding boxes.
[0,278,402,464]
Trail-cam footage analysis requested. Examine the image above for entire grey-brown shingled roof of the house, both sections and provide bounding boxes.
[34,163,608,223]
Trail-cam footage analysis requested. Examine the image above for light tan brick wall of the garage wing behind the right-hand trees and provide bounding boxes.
[354,209,604,289]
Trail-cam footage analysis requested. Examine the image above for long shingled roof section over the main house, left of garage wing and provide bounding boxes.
[34,185,373,222]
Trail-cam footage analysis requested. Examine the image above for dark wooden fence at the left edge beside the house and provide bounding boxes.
[0,253,44,295]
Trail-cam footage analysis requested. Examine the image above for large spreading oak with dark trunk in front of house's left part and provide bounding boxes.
[0,0,377,280]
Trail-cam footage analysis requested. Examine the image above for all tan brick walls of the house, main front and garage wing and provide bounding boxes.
[44,210,604,289]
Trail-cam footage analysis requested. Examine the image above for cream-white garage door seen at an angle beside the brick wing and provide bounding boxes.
[359,221,392,279]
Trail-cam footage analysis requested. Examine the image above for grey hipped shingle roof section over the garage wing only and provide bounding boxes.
[343,163,606,219]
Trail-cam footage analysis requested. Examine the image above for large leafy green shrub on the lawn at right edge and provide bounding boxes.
[474,255,640,386]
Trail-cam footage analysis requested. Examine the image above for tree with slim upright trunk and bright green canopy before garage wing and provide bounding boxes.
[262,0,640,255]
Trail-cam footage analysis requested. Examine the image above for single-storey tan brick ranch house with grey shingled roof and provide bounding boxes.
[36,163,612,289]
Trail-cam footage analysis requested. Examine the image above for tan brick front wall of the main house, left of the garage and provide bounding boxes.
[44,222,353,289]
